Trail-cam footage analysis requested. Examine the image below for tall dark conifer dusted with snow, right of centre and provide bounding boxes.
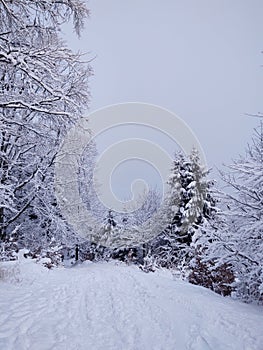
[154,150,217,267]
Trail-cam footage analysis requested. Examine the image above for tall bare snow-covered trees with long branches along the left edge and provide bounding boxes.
[0,0,90,256]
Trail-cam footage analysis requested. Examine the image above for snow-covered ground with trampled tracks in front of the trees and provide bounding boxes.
[0,260,263,350]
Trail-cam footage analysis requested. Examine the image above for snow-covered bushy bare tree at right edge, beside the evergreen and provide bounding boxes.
[193,122,263,303]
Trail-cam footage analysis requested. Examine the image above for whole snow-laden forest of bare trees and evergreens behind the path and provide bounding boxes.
[0,0,263,304]
